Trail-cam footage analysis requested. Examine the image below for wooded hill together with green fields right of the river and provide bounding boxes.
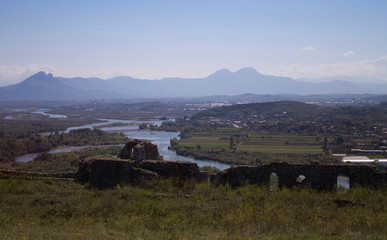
[165,101,387,164]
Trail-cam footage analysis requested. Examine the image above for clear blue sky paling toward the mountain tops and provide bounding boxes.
[0,0,387,86]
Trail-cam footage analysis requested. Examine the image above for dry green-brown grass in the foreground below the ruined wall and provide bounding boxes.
[0,175,387,239]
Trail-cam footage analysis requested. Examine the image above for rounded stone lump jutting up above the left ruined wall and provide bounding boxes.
[119,139,163,162]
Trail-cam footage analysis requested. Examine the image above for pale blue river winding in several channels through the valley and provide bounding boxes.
[16,108,231,170]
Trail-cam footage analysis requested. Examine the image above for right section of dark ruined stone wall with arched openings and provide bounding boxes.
[212,163,387,190]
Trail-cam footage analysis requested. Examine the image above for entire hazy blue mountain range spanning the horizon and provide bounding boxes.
[0,67,387,100]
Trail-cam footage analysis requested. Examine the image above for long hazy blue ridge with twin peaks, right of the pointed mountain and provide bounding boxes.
[58,67,387,98]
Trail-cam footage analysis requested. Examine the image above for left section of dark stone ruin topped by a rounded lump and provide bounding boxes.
[76,139,208,189]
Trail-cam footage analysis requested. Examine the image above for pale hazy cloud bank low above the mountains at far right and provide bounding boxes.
[261,56,387,80]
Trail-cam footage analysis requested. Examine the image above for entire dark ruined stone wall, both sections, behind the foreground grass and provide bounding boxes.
[76,139,387,190]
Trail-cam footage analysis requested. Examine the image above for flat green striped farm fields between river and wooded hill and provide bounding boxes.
[177,131,323,163]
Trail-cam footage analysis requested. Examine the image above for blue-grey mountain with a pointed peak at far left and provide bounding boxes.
[0,72,101,100]
